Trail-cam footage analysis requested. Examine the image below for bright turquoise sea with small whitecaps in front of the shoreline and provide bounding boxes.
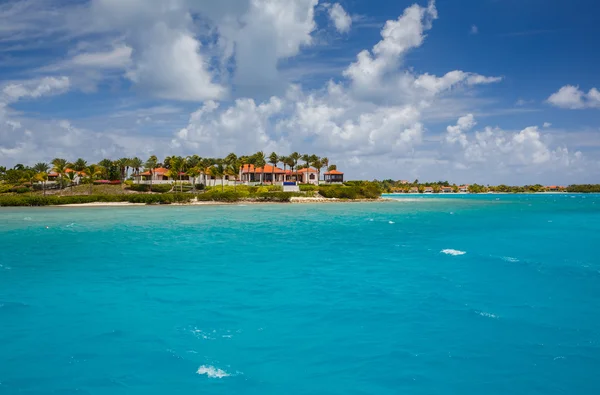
[0,195,600,395]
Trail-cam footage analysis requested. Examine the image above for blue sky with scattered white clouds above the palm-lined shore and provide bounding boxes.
[0,0,600,184]
